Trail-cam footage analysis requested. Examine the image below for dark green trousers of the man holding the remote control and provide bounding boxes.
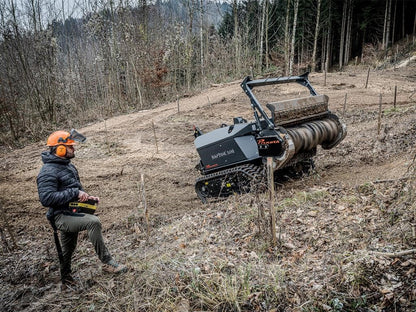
[55,213,112,275]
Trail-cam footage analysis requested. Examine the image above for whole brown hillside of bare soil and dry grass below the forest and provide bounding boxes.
[0,61,416,311]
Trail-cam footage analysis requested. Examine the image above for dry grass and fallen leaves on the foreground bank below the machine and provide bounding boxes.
[22,158,416,311]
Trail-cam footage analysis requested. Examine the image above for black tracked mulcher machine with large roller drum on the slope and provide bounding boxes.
[194,73,347,203]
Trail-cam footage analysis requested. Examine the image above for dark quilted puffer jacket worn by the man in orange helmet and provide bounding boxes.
[37,151,83,210]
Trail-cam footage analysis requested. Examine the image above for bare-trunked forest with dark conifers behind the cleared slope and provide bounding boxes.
[0,0,416,147]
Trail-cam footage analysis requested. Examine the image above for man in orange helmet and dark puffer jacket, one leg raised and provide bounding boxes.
[37,130,127,284]
